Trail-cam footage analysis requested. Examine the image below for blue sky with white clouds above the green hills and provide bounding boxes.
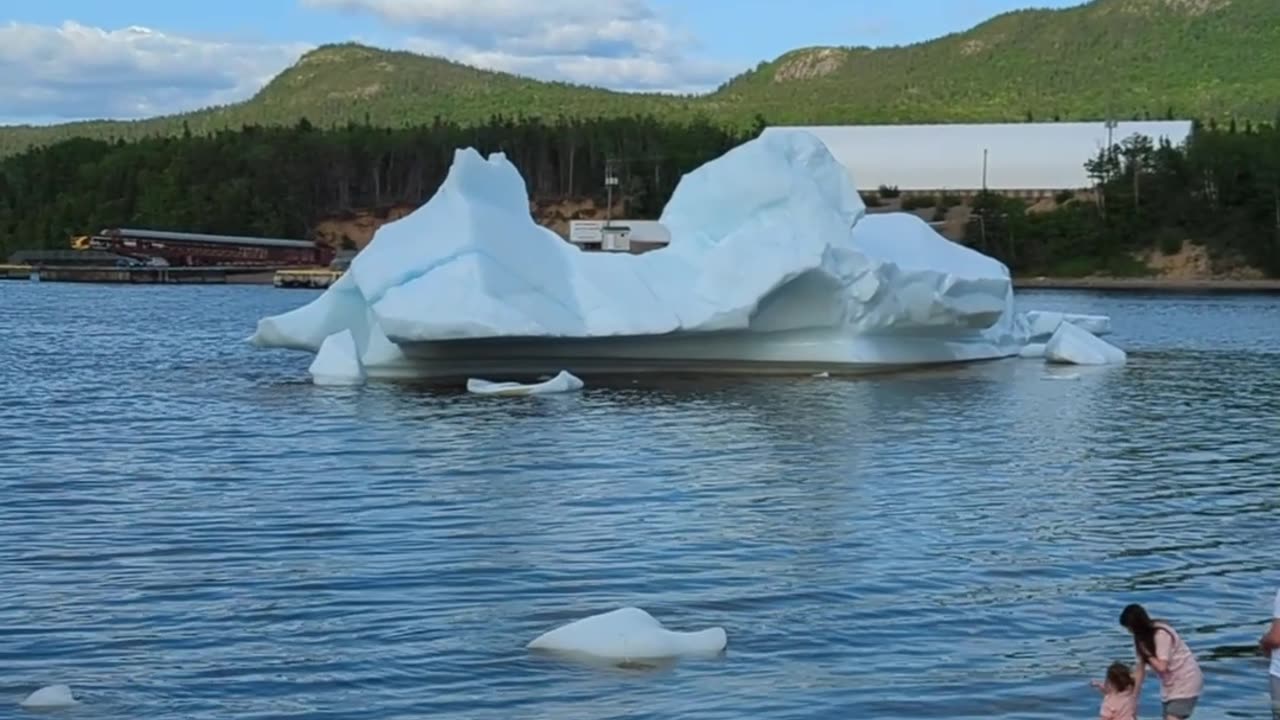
[0,0,1080,124]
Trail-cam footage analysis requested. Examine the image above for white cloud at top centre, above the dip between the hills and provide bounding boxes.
[301,0,742,92]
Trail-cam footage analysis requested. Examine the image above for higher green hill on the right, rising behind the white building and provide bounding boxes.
[714,0,1280,123]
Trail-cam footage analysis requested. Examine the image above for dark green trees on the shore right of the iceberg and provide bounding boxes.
[965,122,1280,277]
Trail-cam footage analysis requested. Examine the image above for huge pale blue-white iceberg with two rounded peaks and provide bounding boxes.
[251,131,1100,378]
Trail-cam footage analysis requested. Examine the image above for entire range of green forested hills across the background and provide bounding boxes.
[0,0,1280,155]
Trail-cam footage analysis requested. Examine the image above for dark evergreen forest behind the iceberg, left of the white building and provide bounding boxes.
[0,117,748,255]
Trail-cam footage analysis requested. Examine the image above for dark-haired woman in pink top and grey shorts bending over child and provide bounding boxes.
[1120,603,1204,720]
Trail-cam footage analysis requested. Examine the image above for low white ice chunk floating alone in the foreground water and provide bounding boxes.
[527,607,728,662]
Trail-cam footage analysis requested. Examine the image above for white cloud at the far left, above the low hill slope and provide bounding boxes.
[0,22,310,123]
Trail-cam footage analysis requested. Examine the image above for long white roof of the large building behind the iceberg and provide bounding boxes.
[764,120,1192,191]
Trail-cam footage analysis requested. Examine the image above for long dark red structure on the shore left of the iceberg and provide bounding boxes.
[72,228,334,266]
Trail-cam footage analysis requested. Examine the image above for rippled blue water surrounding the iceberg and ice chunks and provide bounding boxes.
[0,282,1280,720]
